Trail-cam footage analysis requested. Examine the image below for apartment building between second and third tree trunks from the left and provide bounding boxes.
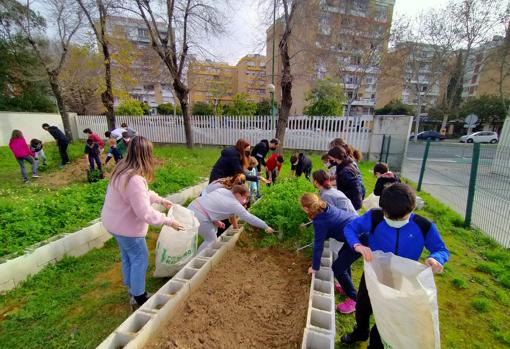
[107,16,175,111]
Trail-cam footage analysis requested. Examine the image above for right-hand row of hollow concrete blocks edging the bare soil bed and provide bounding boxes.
[301,241,336,349]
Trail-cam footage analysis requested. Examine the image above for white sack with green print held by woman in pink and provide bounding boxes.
[154,204,200,277]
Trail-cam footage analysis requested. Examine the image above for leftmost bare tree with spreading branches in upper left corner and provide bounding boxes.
[2,0,82,139]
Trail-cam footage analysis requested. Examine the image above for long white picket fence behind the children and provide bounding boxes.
[77,115,373,152]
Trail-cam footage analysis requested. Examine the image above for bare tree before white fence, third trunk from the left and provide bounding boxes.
[131,0,224,148]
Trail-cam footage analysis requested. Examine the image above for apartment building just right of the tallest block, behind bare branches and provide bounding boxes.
[376,42,450,114]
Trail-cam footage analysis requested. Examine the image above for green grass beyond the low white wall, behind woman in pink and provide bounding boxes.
[0,142,218,257]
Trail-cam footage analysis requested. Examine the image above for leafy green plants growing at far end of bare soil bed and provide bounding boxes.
[251,178,315,245]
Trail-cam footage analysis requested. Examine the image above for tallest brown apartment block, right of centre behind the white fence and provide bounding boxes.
[266,0,395,115]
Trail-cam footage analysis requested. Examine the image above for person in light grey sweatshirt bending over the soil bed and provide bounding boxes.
[188,185,273,252]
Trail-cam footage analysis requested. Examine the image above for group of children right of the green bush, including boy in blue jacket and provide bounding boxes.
[300,139,449,349]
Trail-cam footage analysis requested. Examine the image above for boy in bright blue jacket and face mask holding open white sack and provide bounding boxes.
[341,183,449,349]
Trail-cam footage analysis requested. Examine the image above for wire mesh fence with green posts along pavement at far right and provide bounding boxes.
[402,142,510,248]
